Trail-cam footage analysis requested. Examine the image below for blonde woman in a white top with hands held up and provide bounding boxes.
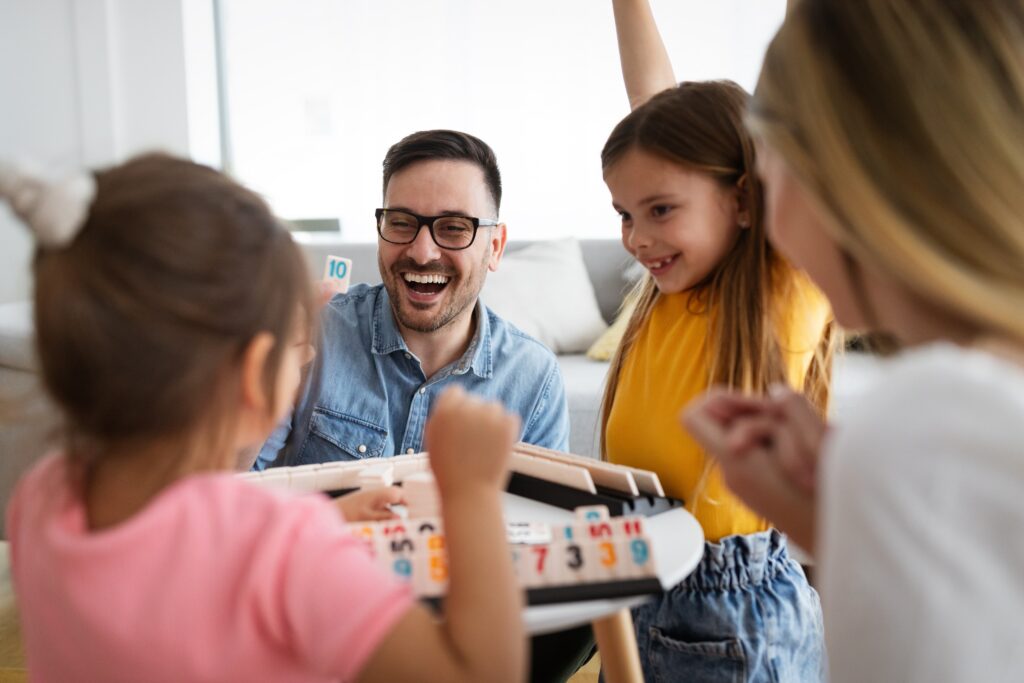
[686,0,1024,683]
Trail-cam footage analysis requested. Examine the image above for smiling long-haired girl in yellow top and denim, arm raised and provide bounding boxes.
[601,0,831,682]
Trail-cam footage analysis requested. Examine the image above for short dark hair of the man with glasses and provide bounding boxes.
[384,130,502,212]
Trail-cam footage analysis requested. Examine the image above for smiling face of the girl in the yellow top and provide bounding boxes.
[604,147,750,294]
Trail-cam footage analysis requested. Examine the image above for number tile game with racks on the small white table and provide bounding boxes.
[240,443,703,605]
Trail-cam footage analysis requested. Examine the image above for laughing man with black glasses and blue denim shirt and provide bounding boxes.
[256,130,593,681]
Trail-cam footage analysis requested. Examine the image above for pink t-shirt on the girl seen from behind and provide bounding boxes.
[7,457,413,682]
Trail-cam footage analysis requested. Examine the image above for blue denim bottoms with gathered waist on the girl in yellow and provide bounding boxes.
[633,529,825,683]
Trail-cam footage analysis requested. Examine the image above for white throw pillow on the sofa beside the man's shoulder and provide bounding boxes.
[480,239,608,353]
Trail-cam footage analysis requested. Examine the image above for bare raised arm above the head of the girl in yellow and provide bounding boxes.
[611,0,676,110]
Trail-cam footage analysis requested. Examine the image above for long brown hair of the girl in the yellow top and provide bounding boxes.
[600,81,834,457]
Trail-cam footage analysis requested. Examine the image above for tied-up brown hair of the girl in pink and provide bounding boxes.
[34,155,314,463]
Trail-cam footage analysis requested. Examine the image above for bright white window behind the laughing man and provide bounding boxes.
[220,0,785,241]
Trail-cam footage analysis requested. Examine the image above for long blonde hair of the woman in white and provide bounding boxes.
[749,0,1024,339]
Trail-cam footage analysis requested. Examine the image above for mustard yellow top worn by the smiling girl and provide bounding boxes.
[606,281,831,542]
